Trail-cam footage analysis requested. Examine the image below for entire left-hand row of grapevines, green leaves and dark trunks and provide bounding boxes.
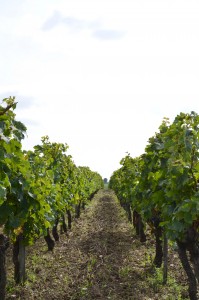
[0,97,103,299]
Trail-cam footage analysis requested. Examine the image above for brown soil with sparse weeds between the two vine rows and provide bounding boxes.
[4,190,187,300]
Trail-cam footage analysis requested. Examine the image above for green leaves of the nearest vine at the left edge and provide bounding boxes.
[0,97,34,241]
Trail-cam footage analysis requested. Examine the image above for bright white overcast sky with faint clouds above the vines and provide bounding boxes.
[0,0,199,178]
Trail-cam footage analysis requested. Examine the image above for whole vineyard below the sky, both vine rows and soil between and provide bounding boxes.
[0,97,199,300]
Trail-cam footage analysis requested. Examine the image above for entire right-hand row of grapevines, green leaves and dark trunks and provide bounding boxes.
[109,112,199,300]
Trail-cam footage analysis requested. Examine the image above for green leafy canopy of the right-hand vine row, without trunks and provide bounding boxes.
[109,112,199,240]
